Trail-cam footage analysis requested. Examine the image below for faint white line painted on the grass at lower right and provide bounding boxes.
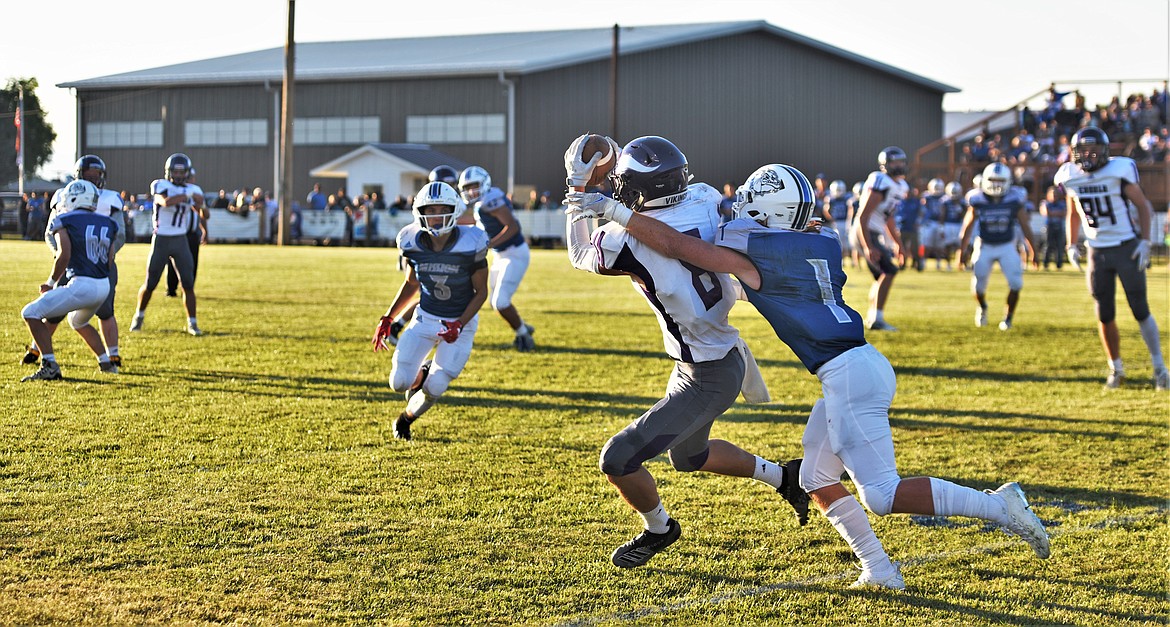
[557,508,1168,627]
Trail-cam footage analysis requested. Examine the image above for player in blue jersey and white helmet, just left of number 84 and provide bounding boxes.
[959,163,1035,331]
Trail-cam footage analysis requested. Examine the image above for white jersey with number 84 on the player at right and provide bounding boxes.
[1053,157,1140,248]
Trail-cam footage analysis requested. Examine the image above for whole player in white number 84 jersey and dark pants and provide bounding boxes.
[1054,126,1170,391]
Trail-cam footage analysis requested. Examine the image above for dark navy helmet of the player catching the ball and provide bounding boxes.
[610,135,690,212]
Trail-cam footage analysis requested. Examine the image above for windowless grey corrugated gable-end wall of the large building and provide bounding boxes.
[517,33,943,198]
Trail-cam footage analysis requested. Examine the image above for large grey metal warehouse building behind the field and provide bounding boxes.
[59,21,957,199]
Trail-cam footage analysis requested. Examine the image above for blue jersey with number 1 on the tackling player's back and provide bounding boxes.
[715,219,866,373]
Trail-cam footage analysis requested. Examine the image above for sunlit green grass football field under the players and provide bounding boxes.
[0,240,1170,626]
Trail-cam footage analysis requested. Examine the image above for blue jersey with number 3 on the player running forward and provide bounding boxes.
[397,223,488,319]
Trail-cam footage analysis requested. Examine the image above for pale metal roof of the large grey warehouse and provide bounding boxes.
[57,20,959,92]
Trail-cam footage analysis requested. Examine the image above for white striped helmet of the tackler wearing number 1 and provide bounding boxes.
[732,164,817,230]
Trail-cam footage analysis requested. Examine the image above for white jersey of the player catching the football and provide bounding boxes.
[592,182,739,363]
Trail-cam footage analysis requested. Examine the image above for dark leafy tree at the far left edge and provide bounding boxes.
[0,78,57,184]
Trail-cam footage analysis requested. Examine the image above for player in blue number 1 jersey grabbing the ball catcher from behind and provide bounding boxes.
[582,164,1049,590]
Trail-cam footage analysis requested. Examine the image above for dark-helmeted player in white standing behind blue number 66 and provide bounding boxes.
[23,154,126,374]
